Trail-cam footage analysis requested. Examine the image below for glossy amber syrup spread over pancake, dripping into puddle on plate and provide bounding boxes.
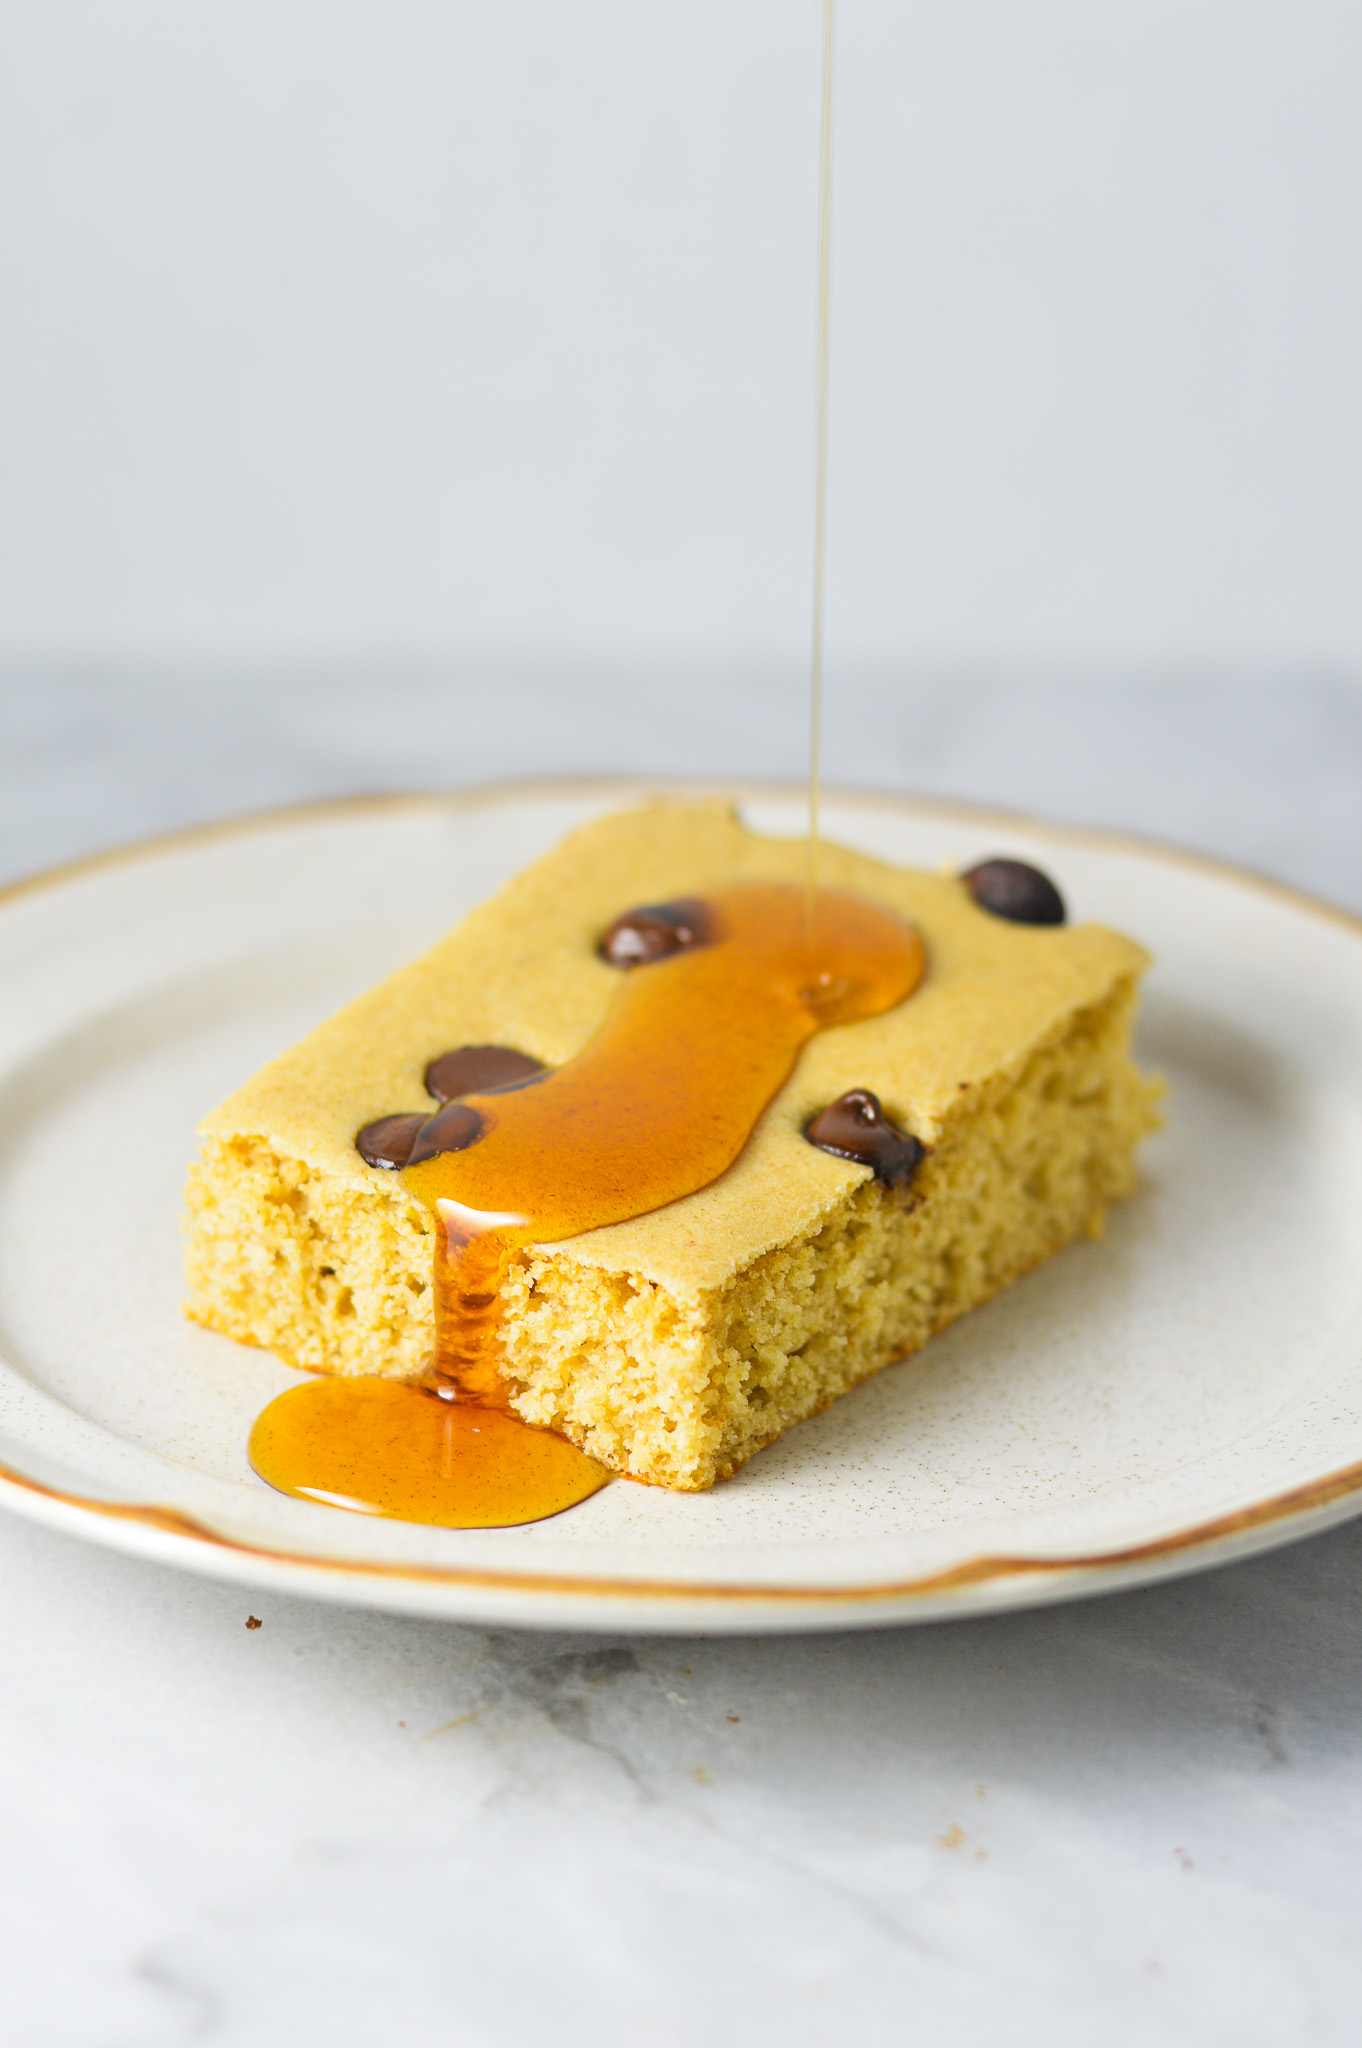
[250,883,924,1528]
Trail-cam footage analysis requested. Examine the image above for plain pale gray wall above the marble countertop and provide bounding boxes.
[0,0,1362,670]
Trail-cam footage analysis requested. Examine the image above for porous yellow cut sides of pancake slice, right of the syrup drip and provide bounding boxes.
[493,987,1153,1489]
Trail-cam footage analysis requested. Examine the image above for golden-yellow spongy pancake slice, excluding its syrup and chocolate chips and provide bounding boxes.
[186,807,1159,1491]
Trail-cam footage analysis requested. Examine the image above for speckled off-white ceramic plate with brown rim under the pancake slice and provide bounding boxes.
[0,782,1362,1632]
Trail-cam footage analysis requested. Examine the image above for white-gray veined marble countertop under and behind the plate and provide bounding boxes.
[0,664,1362,2048]
